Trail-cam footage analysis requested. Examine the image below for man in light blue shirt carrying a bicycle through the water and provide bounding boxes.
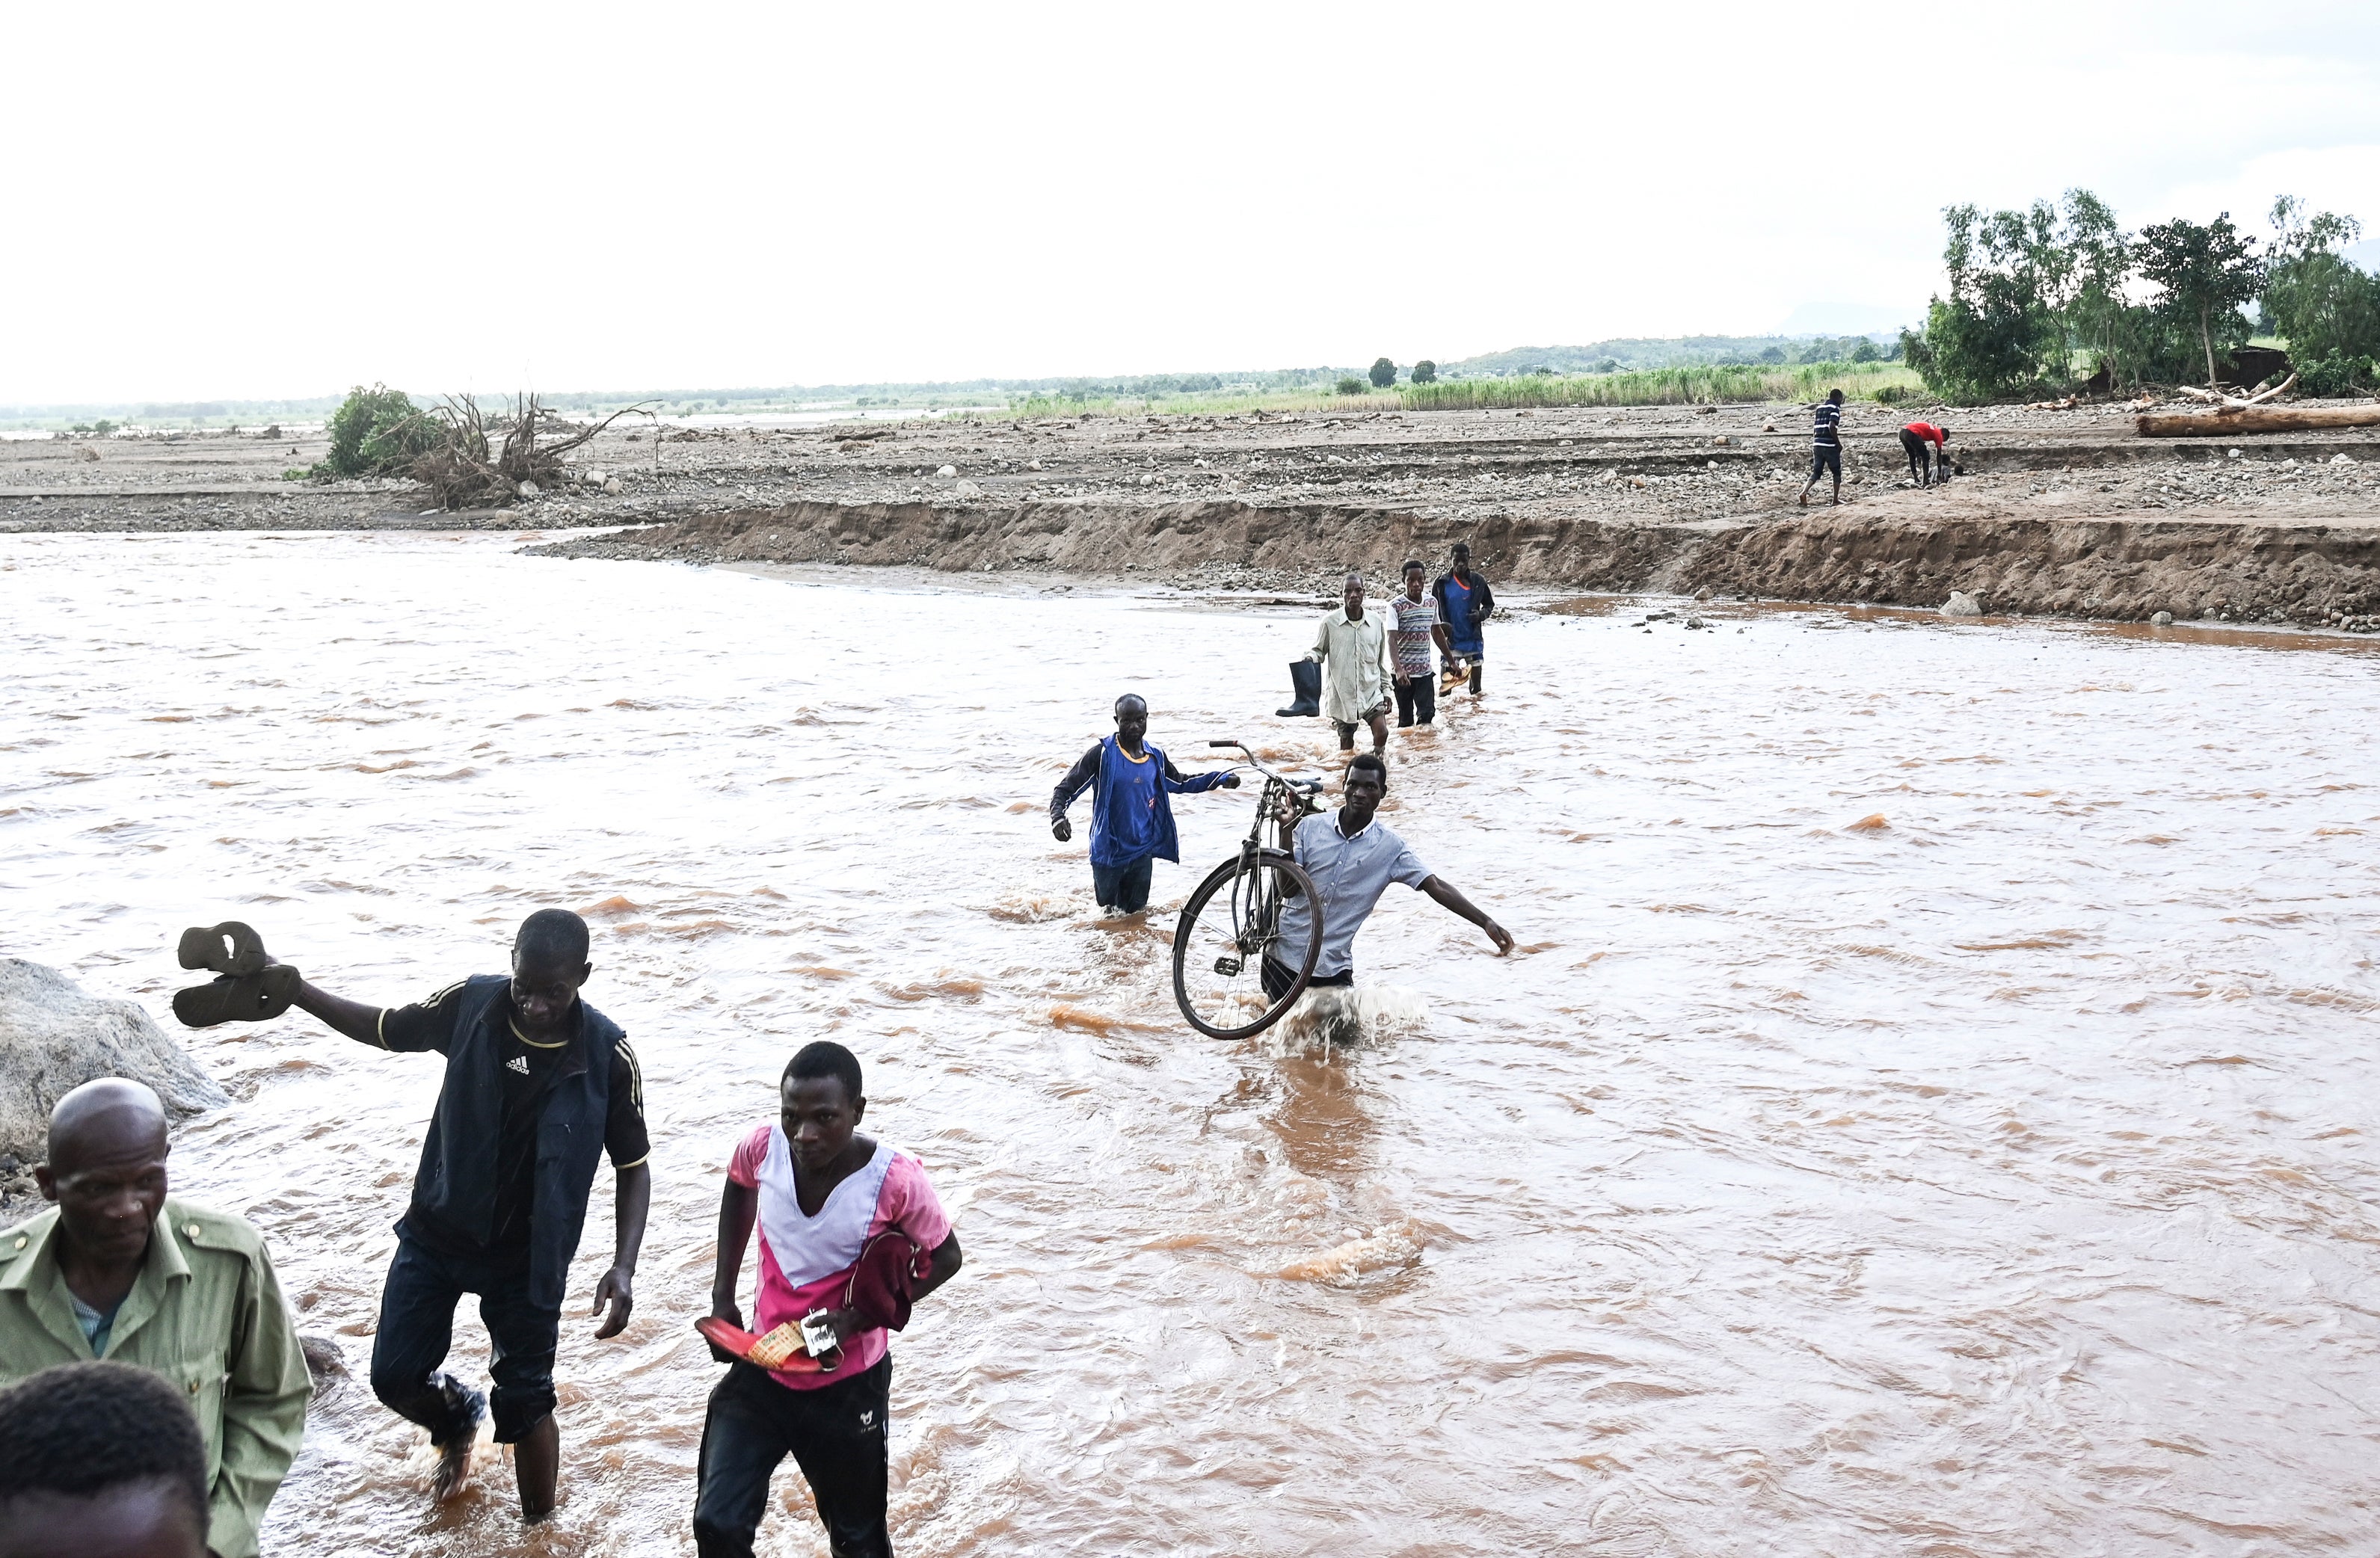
[1264,751,1511,1001]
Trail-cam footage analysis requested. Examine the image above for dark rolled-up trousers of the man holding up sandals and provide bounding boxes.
[372,1234,562,1444]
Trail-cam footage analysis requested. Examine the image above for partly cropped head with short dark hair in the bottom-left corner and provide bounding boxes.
[0,1363,207,1558]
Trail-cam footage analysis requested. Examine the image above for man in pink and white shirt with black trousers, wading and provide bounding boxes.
[695,1042,959,1558]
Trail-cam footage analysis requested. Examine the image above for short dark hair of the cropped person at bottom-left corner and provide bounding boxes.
[0,1363,207,1534]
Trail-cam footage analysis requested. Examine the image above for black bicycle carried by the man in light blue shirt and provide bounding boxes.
[1173,742,1323,1039]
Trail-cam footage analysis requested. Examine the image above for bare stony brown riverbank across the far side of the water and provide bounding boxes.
[13,404,2380,623]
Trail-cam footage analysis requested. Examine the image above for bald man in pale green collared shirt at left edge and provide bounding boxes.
[0,1077,312,1558]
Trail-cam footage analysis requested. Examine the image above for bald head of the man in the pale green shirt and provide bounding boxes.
[34,1077,169,1263]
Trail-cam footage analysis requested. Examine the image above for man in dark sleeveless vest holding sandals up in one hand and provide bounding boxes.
[277,908,652,1522]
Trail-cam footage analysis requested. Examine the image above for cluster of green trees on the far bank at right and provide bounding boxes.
[1901,191,2380,402]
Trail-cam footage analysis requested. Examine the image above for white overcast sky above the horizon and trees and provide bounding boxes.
[0,0,2380,404]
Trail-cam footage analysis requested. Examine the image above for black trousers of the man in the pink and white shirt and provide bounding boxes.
[695,1356,893,1558]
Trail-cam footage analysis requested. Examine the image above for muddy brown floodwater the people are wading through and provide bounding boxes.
[0,533,2380,1558]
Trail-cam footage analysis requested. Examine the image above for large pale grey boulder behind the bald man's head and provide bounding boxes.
[0,958,231,1163]
